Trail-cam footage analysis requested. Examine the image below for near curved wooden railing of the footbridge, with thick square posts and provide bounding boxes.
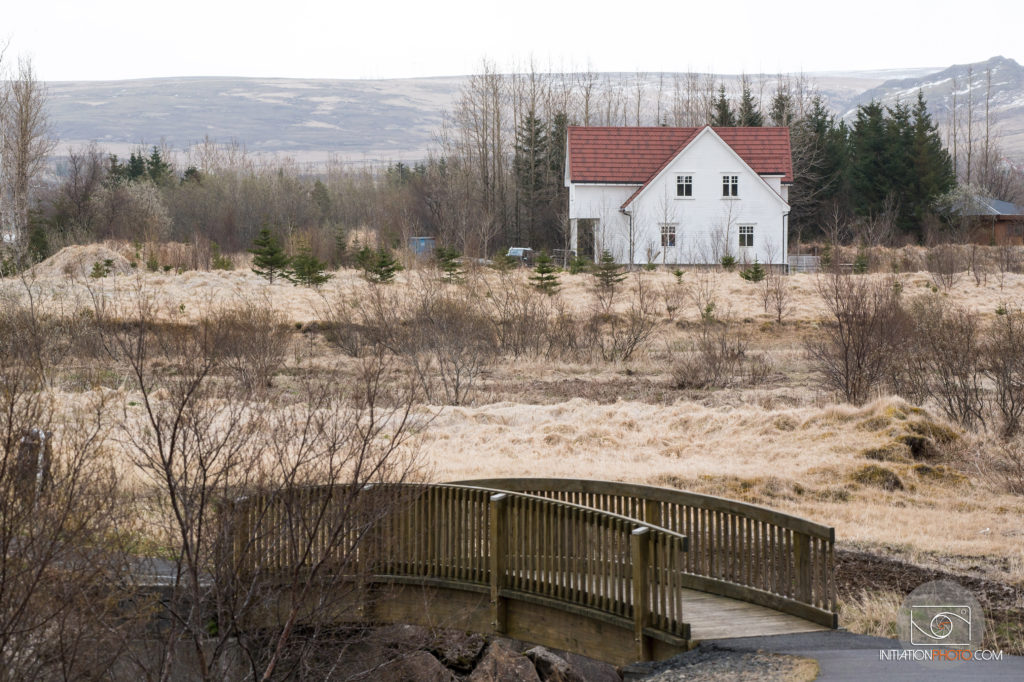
[231,477,689,658]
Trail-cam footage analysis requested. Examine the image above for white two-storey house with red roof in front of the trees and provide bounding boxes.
[565,126,793,264]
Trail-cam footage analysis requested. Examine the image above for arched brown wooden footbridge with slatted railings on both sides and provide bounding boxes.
[231,478,837,665]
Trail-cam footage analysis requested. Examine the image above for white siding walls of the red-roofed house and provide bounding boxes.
[569,130,788,264]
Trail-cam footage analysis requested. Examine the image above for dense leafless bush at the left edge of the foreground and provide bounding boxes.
[0,294,135,680]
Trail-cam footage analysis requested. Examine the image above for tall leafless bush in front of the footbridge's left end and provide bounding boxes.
[88,284,418,679]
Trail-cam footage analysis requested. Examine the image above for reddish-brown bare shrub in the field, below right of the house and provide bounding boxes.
[804,274,904,404]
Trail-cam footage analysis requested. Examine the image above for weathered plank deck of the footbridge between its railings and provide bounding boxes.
[682,590,829,641]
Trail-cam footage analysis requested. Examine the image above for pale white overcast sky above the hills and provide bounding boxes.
[8,0,1024,81]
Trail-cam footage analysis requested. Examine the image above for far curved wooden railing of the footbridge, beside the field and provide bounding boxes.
[460,478,838,628]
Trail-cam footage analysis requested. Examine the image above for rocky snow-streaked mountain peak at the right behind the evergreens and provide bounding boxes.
[844,56,1024,161]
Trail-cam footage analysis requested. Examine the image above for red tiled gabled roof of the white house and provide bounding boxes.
[568,126,793,204]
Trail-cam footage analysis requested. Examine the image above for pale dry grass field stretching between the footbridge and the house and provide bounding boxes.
[8,244,1024,641]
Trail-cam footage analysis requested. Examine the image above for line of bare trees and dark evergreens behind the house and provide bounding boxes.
[0,57,1020,269]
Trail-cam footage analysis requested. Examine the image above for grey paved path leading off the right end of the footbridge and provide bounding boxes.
[704,630,1024,682]
